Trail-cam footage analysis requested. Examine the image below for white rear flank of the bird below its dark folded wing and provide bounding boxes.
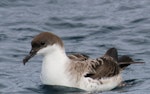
[80,74,122,91]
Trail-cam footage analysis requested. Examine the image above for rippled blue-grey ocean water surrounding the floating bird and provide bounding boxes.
[0,0,150,94]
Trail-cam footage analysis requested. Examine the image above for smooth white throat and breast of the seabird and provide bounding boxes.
[39,44,70,86]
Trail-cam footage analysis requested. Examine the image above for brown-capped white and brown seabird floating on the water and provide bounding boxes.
[23,32,142,91]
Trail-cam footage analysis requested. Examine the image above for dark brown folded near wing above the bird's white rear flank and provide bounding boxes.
[85,56,120,79]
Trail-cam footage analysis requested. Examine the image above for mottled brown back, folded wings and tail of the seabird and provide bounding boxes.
[68,48,143,79]
